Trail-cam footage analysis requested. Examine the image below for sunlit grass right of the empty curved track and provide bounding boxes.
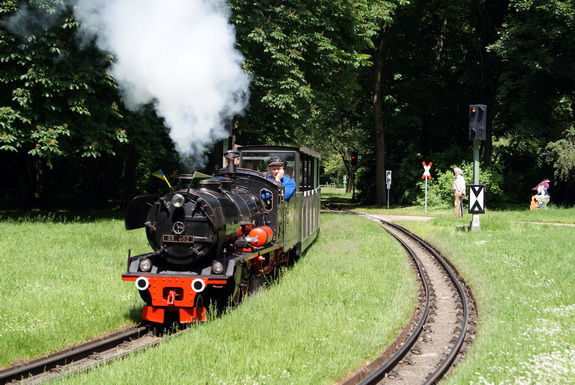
[402,213,575,385]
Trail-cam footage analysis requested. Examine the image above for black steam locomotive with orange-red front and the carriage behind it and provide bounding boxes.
[122,146,320,324]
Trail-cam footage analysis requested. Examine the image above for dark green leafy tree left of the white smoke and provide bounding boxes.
[0,0,178,207]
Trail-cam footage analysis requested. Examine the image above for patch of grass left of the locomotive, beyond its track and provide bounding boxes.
[0,215,148,367]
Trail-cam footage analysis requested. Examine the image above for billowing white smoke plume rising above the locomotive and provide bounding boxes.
[74,0,250,164]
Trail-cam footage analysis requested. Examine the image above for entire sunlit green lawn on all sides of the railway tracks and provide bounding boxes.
[0,202,575,384]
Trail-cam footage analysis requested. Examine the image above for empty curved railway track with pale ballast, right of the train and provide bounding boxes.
[343,215,477,385]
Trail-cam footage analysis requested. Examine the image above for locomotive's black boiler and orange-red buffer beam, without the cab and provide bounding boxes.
[122,177,273,323]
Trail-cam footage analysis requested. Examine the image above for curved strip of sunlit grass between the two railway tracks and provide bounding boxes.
[50,215,417,385]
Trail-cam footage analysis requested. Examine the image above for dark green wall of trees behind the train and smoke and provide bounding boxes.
[0,0,575,208]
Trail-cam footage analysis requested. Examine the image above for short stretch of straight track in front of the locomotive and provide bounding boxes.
[0,326,164,385]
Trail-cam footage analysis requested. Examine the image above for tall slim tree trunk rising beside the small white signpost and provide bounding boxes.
[372,24,389,206]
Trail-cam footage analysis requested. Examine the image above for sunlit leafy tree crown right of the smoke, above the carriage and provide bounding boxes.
[230,0,400,142]
